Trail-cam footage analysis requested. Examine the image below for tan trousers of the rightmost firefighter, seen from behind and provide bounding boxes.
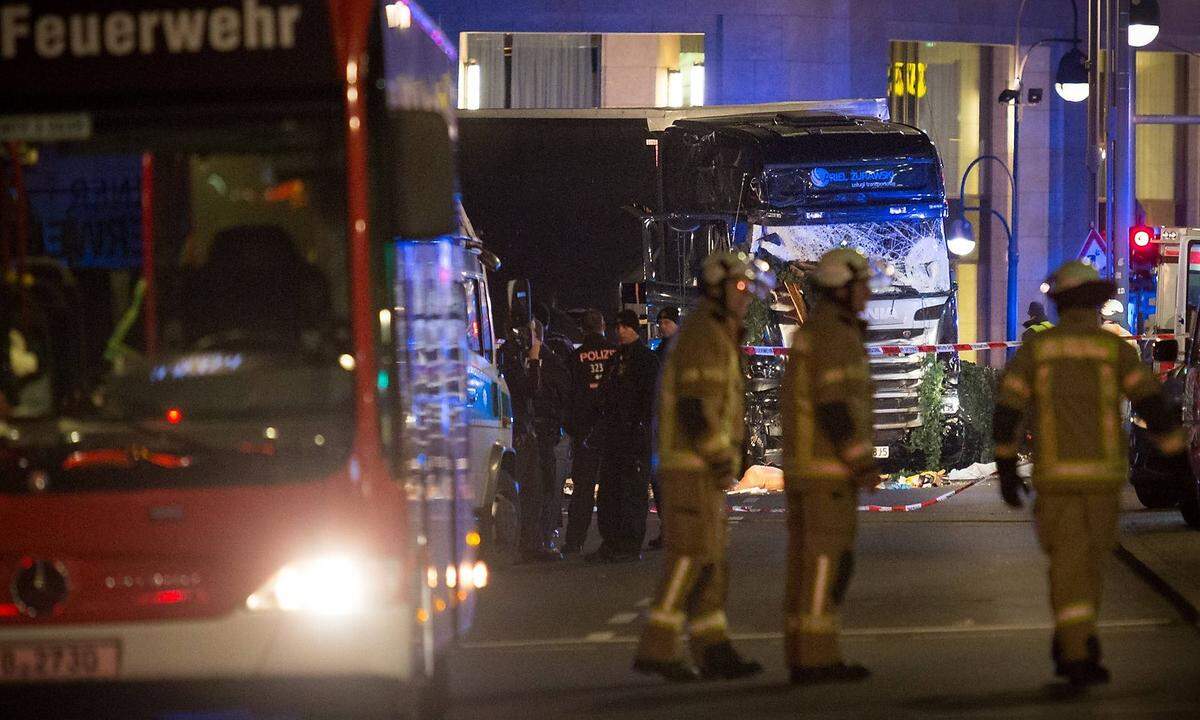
[1033,489,1120,662]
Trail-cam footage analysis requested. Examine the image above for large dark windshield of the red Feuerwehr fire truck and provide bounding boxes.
[7,118,353,422]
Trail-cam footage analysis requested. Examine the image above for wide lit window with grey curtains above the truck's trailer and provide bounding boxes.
[458,32,706,109]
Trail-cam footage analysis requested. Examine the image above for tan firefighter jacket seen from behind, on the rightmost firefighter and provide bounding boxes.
[996,310,1183,493]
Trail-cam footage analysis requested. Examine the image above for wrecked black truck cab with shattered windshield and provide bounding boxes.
[647,101,965,467]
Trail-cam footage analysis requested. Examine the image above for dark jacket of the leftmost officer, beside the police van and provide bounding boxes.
[500,342,570,440]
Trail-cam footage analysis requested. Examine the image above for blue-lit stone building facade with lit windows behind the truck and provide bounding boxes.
[425,0,1200,355]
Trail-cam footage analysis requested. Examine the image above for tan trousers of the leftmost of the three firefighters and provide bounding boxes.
[637,552,730,664]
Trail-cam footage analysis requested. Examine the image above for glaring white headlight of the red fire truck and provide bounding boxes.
[246,554,401,614]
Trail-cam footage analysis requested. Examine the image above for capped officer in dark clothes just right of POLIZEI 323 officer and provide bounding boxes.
[587,310,659,563]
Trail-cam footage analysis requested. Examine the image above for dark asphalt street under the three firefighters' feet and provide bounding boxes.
[451,481,1200,720]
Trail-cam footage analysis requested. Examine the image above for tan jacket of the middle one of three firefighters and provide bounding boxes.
[780,300,874,491]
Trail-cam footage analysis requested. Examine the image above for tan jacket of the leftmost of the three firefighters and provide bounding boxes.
[658,299,745,477]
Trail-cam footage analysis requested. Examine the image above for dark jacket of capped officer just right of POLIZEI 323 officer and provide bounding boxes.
[588,340,659,452]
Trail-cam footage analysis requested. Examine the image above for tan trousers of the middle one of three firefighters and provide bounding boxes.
[784,485,858,668]
